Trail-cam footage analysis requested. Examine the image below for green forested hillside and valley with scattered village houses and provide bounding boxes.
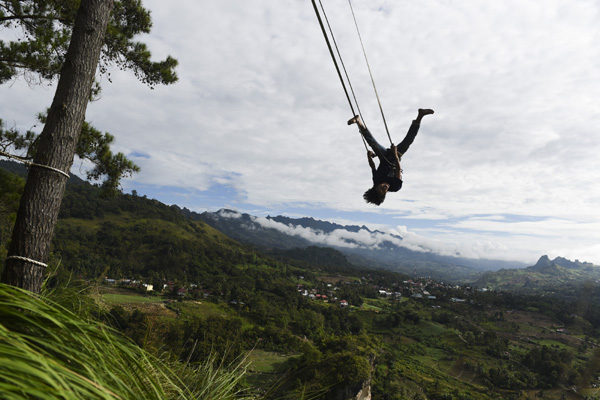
[0,164,600,400]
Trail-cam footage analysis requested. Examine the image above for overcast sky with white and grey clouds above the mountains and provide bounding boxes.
[0,0,600,265]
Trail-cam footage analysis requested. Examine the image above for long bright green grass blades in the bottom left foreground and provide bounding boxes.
[0,284,252,400]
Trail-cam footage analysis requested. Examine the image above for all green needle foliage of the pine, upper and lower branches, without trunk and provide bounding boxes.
[0,0,177,195]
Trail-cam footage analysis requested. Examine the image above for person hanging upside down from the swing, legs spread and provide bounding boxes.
[348,108,433,205]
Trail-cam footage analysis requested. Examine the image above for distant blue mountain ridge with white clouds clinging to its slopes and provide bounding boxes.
[195,209,525,282]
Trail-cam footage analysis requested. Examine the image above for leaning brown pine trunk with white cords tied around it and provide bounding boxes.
[2,0,113,293]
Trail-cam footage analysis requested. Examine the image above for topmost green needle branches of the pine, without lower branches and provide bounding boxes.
[0,0,177,86]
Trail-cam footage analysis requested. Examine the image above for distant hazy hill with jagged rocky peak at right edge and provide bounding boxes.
[473,256,600,291]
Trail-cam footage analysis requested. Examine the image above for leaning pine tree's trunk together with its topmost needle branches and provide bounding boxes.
[0,0,177,292]
